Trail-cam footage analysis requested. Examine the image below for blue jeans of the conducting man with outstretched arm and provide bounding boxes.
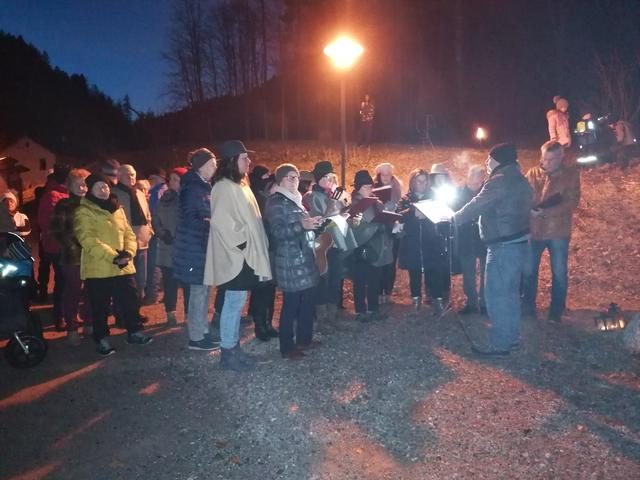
[484,242,529,351]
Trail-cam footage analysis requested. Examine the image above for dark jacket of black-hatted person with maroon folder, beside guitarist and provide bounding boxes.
[350,193,393,267]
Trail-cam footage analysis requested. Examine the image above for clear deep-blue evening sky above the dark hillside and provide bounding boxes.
[0,0,171,112]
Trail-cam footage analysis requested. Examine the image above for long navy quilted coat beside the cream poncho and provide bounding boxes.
[174,170,211,285]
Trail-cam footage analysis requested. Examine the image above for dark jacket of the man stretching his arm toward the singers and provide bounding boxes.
[453,163,533,244]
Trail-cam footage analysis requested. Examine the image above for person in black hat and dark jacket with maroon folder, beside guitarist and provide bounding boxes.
[350,170,393,322]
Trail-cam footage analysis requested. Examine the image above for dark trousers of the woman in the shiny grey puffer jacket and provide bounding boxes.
[280,288,315,354]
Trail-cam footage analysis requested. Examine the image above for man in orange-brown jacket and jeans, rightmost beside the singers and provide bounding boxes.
[522,141,580,322]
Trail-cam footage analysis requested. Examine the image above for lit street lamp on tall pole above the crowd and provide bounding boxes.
[323,37,364,187]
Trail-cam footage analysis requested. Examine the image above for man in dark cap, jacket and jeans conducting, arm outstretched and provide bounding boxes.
[452,143,532,355]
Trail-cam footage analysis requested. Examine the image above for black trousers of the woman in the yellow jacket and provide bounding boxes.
[84,275,142,342]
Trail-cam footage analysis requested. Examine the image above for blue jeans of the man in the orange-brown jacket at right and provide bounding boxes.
[523,238,569,315]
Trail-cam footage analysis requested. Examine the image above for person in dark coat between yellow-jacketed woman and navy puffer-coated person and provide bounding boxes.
[152,167,189,325]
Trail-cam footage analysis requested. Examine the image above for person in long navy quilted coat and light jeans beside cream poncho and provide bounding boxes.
[173,148,217,350]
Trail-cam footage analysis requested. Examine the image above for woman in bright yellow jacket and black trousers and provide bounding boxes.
[73,174,151,356]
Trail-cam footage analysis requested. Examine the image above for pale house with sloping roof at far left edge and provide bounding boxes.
[0,137,56,202]
